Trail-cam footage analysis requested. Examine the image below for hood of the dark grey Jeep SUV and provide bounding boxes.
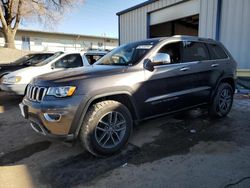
[33,65,127,83]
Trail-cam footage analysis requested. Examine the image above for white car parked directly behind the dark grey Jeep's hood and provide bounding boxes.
[0,52,90,95]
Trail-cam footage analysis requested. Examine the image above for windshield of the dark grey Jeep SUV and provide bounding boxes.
[95,39,159,66]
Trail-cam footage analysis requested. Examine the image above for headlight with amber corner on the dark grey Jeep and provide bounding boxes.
[47,86,76,97]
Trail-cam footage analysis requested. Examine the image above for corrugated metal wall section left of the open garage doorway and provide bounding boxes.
[119,0,183,44]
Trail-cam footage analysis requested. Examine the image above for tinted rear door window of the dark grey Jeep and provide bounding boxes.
[182,41,210,62]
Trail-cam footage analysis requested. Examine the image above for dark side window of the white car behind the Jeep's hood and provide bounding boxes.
[55,54,83,68]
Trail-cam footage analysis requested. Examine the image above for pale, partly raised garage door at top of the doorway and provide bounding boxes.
[150,0,200,25]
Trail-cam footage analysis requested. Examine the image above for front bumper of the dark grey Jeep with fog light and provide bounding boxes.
[20,95,84,140]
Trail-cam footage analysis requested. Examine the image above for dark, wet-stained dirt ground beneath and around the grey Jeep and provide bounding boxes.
[0,91,250,188]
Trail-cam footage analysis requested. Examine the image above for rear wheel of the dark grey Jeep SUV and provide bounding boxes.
[209,83,234,118]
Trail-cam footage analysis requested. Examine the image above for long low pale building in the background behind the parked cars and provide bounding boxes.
[0,28,118,52]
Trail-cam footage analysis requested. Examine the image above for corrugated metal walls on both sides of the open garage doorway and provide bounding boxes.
[120,0,250,69]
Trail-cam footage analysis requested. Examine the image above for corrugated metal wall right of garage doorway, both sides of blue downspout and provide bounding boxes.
[199,0,250,69]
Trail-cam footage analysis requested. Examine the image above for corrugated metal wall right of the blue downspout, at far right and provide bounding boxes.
[220,0,250,69]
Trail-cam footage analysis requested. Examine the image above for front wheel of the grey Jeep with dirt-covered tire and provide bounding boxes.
[79,100,133,156]
